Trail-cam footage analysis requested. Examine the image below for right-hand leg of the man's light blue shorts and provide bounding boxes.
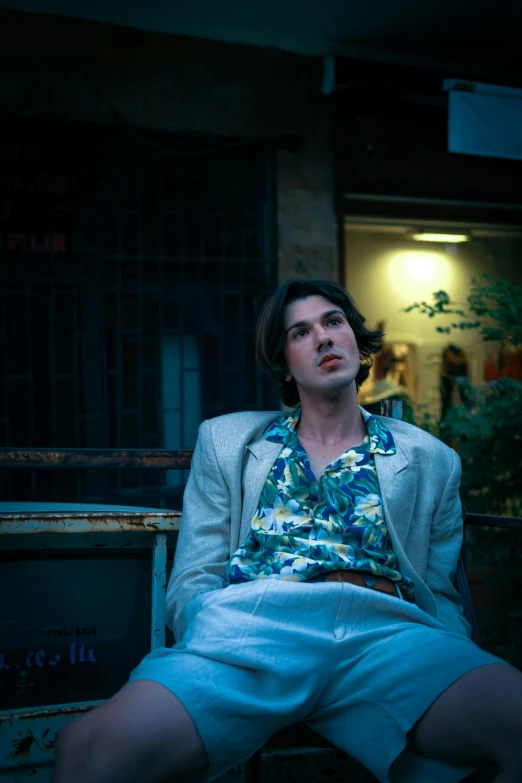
[309,585,501,782]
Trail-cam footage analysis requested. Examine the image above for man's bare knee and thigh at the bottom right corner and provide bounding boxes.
[409,664,522,783]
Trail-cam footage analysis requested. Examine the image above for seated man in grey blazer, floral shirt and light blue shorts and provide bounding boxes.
[54,281,522,783]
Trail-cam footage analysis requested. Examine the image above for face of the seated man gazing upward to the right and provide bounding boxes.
[285,295,360,402]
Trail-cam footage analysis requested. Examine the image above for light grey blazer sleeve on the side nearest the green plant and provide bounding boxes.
[425,449,471,638]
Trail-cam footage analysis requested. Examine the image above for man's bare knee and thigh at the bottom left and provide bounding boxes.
[52,680,208,783]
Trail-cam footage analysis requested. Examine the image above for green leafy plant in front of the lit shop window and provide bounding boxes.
[405,275,522,667]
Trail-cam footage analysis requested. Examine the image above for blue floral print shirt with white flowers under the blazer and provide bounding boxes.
[225,408,415,594]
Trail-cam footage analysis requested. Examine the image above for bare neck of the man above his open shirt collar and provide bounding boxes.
[297,385,367,447]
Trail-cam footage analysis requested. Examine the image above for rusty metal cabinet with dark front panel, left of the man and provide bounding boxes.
[0,500,181,783]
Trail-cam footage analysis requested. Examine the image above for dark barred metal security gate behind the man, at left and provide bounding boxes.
[0,120,277,508]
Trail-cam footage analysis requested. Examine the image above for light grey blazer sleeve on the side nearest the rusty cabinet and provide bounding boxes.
[166,421,231,642]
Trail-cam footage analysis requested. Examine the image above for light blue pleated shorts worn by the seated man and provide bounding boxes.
[130,579,503,783]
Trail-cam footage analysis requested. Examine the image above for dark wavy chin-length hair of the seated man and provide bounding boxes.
[256,280,383,408]
